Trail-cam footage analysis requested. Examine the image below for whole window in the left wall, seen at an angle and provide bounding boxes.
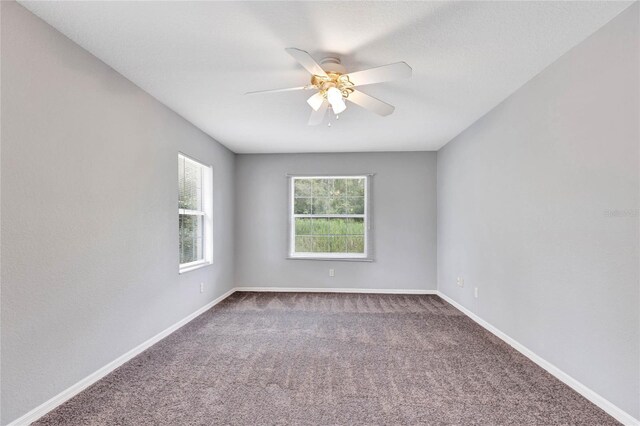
[178,154,213,272]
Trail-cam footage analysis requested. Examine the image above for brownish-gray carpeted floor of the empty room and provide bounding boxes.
[35,293,617,426]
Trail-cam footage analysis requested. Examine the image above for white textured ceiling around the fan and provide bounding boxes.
[21,1,631,153]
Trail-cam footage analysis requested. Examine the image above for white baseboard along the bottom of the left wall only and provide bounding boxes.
[7,288,236,426]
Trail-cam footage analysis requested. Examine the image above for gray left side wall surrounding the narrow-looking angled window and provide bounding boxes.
[1,2,234,424]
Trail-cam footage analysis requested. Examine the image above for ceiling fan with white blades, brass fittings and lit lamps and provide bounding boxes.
[246,47,411,126]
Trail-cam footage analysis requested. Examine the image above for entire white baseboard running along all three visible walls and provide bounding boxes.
[7,287,640,426]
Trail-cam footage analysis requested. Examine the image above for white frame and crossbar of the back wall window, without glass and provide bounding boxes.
[287,174,373,262]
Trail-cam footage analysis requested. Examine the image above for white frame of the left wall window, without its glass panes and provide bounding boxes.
[178,152,213,274]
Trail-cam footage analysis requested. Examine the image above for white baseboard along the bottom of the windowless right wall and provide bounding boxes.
[438,292,640,426]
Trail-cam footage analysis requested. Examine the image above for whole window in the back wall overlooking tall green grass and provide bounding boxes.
[289,176,370,260]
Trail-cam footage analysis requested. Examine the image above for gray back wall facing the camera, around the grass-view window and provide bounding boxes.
[236,152,436,290]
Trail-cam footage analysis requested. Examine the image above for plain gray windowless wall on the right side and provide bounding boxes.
[438,3,640,418]
